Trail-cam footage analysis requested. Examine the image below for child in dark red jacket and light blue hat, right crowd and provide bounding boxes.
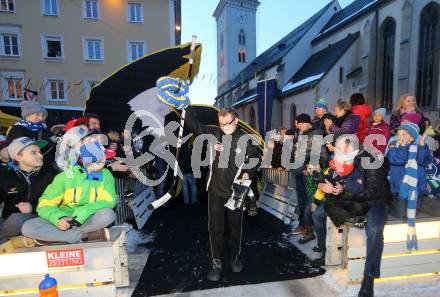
[364,108,391,154]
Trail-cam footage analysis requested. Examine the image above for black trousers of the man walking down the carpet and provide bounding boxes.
[208,192,243,260]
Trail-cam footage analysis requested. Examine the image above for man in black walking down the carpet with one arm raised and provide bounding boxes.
[185,106,260,281]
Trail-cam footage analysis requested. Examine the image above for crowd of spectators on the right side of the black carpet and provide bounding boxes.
[269,93,440,297]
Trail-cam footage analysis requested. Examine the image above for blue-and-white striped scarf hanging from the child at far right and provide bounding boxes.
[399,140,418,251]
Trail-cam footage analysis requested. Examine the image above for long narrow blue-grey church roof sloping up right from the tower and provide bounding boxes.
[217,1,333,98]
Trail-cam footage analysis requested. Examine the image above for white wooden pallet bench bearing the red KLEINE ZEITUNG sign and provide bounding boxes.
[0,227,129,297]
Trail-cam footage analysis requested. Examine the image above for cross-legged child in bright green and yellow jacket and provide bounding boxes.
[22,139,116,244]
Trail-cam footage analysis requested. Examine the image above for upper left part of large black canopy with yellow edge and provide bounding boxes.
[85,43,202,131]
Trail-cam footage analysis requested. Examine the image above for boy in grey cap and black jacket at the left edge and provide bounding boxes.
[0,137,56,243]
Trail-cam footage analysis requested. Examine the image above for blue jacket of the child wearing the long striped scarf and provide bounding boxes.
[387,140,432,195]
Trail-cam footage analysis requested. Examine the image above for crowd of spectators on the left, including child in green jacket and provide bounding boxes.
[0,101,156,246]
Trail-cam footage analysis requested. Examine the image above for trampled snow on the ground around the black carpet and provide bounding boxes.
[117,224,440,297]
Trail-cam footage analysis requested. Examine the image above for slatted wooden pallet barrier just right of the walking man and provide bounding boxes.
[258,168,298,224]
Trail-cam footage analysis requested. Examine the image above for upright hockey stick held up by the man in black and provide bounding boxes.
[148,35,197,210]
